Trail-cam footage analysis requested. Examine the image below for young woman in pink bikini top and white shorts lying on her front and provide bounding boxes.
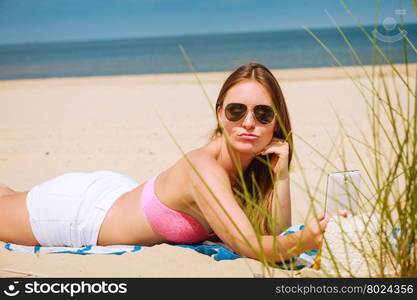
[0,63,328,262]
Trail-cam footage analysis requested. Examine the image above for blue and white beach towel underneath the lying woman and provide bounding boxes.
[5,224,317,270]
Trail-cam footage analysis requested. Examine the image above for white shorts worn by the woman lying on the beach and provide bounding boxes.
[26,171,138,247]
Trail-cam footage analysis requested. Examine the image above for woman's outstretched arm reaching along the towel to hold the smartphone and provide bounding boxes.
[187,158,322,261]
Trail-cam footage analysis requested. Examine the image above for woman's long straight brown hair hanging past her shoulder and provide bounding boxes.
[210,62,294,234]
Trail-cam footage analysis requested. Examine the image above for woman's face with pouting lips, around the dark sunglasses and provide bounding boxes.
[217,79,277,155]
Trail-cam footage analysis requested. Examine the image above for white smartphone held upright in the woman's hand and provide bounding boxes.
[325,170,361,216]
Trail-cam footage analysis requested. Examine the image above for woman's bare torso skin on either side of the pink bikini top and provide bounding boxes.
[97,145,216,246]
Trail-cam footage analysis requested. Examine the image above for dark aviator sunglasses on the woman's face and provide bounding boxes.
[225,103,275,124]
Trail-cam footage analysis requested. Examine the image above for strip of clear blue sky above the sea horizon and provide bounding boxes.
[0,0,417,44]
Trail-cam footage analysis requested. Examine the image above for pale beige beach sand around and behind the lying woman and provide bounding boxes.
[0,65,416,277]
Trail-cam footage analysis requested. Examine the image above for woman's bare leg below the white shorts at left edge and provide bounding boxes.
[0,186,39,246]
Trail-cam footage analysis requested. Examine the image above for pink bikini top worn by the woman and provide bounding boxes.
[142,176,215,244]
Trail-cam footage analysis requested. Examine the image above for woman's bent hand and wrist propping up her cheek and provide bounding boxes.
[258,138,290,179]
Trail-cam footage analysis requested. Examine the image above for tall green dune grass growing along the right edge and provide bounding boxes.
[306,1,417,277]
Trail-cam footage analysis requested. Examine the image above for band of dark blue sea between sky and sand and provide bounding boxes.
[0,23,417,80]
